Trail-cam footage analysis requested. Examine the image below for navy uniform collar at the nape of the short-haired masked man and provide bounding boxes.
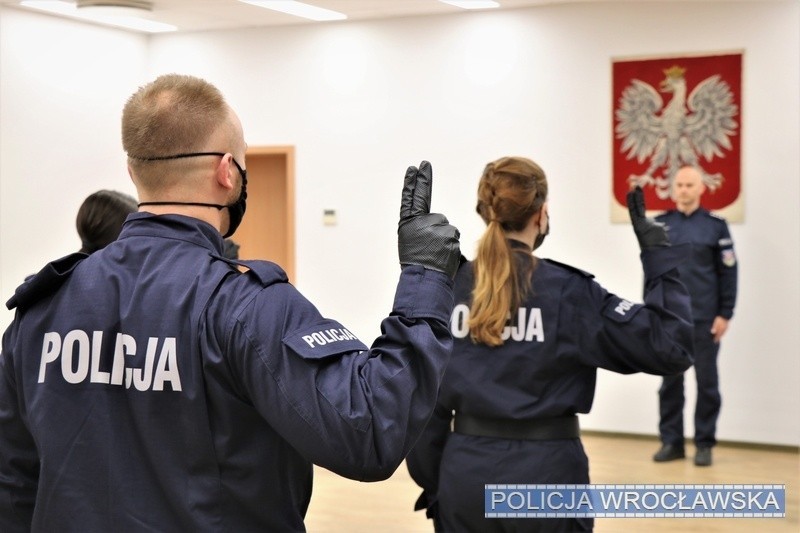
[119,212,223,255]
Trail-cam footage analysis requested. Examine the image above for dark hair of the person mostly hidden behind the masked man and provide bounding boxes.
[75,190,138,254]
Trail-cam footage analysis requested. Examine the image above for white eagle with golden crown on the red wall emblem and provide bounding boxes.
[614,65,738,199]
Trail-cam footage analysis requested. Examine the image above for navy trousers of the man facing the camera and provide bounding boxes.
[658,321,722,447]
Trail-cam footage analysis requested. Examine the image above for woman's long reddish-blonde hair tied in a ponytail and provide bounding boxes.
[469,157,547,346]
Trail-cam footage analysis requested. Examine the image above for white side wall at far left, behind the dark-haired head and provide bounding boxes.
[0,9,147,310]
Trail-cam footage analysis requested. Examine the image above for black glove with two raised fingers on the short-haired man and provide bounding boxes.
[397,161,461,278]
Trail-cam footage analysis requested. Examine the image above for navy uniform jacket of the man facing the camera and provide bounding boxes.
[656,208,738,321]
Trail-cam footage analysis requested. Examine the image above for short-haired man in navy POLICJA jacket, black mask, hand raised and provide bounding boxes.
[0,74,460,533]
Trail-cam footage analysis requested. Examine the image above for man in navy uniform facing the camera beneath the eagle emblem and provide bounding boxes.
[653,166,738,466]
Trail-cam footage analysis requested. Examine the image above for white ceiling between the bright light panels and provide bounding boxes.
[0,0,579,32]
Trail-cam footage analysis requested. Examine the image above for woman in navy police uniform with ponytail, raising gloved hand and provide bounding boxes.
[407,157,692,533]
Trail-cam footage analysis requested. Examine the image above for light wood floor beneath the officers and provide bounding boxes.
[306,434,800,533]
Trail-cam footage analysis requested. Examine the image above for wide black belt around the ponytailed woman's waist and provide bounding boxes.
[453,413,581,440]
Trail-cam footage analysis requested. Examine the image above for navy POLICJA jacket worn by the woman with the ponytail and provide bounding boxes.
[407,240,693,506]
